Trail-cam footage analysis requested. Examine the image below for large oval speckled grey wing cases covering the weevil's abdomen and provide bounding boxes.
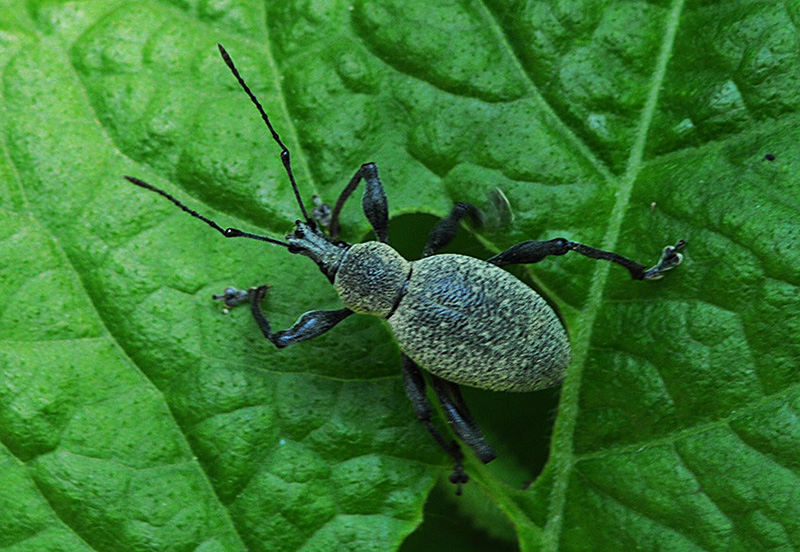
[388,255,572,391]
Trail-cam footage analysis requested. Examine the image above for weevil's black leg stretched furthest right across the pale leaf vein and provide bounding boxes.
[487,238,686,280]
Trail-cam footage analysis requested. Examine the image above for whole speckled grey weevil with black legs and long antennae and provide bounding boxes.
[125,45,686,494]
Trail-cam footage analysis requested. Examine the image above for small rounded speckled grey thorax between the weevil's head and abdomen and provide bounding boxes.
[333,242,411,317]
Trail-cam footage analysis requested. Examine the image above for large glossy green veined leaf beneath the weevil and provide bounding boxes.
[0,0,800,552]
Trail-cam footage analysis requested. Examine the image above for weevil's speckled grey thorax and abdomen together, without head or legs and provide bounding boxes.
[333,242,571,391]
